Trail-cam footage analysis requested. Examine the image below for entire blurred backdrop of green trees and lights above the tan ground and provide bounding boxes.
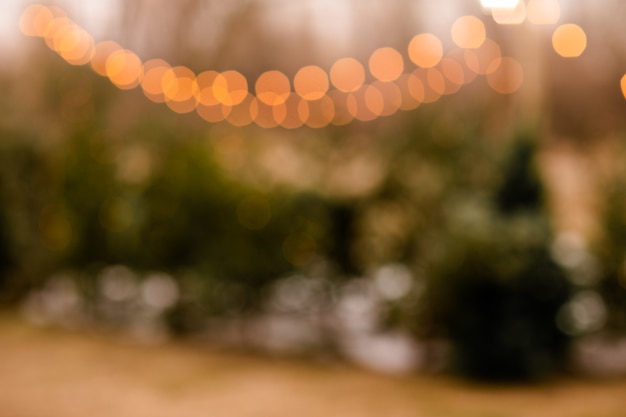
[0,0,626,396]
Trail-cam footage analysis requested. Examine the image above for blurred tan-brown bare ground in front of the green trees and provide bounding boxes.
[0,316,626,417]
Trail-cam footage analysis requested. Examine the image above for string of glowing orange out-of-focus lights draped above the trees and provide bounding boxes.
[20,0,604,129]
